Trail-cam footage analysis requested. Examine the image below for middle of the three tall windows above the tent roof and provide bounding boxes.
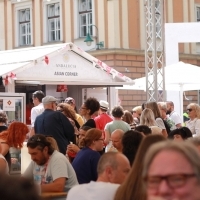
[47,3,60,42]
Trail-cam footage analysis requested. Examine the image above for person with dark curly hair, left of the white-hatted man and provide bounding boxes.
[79,97,100,128]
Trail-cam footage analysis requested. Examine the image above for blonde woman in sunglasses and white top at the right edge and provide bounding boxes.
[186,103,200,136]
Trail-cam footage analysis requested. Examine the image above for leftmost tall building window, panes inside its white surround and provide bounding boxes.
[19,9,31,46]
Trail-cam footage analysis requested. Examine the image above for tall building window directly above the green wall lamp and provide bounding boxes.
[78,0,93,37]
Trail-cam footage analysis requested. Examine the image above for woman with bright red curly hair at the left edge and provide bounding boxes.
[0,122,29,169]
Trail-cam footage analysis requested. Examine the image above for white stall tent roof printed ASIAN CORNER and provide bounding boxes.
[0,43,133,85]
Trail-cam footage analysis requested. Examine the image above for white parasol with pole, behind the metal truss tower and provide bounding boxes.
[117,62,200,119]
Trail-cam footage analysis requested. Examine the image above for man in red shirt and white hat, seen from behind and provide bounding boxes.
[94,100,113,152]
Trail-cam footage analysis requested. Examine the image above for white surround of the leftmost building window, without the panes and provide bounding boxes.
[14,2,33,47]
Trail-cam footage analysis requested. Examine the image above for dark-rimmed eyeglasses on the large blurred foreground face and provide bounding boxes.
[144,174,196,189]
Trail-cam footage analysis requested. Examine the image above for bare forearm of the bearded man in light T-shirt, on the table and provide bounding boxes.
[41,177,66,192]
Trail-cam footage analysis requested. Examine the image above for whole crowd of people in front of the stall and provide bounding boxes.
[0,91,200,200]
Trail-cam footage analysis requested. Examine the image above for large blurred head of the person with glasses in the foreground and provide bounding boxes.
[142,141,200,200]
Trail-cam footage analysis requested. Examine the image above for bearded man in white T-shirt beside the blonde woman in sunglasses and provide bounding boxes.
[166,101,182,128]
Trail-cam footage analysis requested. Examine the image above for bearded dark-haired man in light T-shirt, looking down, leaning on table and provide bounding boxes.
[23,134,78,192]
